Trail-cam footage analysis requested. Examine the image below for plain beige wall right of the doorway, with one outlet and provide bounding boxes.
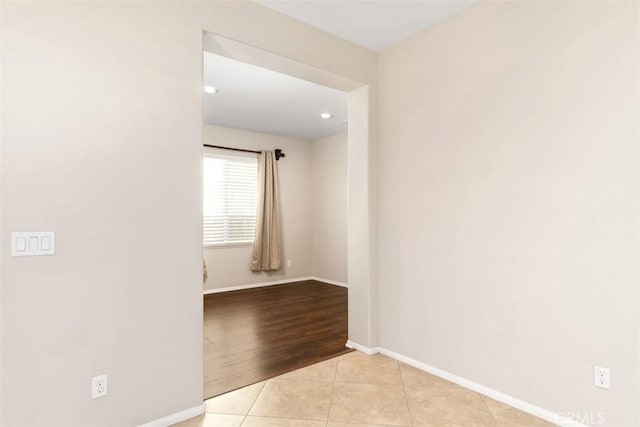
[378,2,640,426]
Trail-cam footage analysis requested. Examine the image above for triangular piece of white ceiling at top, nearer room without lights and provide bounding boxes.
[255,0,478,52]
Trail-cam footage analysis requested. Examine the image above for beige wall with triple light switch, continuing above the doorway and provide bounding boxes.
[0,2,376,427]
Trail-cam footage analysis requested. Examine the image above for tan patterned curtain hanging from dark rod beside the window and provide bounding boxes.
[251,151,282,271]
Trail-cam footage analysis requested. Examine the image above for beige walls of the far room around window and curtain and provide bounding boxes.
[204,125,313,290]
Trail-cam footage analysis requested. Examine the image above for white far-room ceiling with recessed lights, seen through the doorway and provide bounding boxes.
[203,52,347,139]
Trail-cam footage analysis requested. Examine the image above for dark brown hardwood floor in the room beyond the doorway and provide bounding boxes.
[204,280,350,399]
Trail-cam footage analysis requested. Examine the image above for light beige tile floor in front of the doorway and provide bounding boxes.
[176,352,551,427]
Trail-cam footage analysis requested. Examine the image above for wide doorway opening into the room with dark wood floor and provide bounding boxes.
[203,34,360,398]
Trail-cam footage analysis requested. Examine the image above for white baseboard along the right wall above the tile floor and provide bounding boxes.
[346,340,586,427]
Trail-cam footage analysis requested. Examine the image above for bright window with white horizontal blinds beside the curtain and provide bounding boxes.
[202,153,258,246]
